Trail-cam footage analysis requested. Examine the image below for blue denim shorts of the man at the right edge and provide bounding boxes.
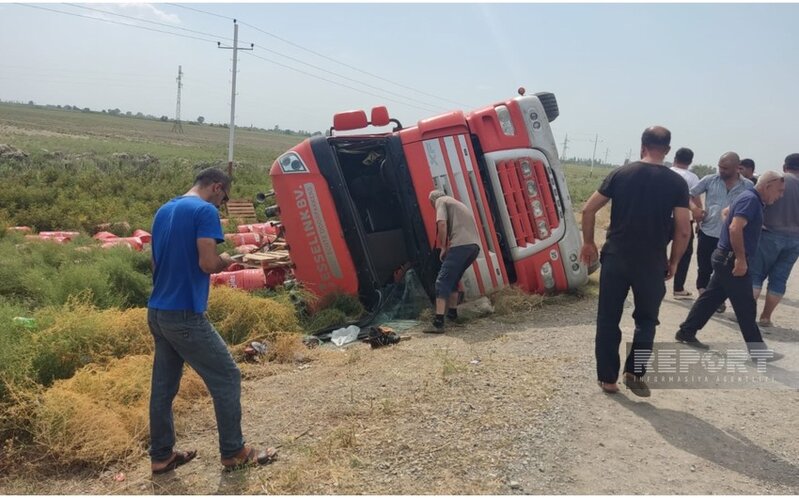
[750,230,799,297]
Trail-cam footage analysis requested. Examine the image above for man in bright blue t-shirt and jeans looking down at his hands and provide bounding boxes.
[147,168,277,474]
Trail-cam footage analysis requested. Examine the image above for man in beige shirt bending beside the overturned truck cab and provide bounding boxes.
[425,190,480,334]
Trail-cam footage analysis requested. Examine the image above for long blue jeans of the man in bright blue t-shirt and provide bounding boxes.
[147,308,244,461]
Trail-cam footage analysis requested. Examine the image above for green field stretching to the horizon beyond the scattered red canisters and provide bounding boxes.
[0,104,302,233]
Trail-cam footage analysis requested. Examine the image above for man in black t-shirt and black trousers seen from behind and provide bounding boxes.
[580,126,691,396]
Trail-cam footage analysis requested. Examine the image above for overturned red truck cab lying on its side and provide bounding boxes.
[267,89,588,306]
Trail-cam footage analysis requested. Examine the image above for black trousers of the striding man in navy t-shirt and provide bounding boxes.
[680,250,765,350]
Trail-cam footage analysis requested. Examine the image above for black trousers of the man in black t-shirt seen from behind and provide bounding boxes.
[595,253,666,383]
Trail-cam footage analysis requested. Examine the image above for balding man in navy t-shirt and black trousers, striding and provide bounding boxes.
[675,171,785,361]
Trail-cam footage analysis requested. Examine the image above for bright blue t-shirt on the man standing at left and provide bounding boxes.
[147,196,225,313]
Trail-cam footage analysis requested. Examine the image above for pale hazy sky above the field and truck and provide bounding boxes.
[0,3,799,170]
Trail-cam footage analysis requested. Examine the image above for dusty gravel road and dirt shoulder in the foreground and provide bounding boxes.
[0,266,799,494]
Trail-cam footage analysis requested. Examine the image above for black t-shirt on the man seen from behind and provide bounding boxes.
[599,161,688,261]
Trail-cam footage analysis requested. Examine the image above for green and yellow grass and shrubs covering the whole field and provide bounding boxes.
[0,104,606,474]
